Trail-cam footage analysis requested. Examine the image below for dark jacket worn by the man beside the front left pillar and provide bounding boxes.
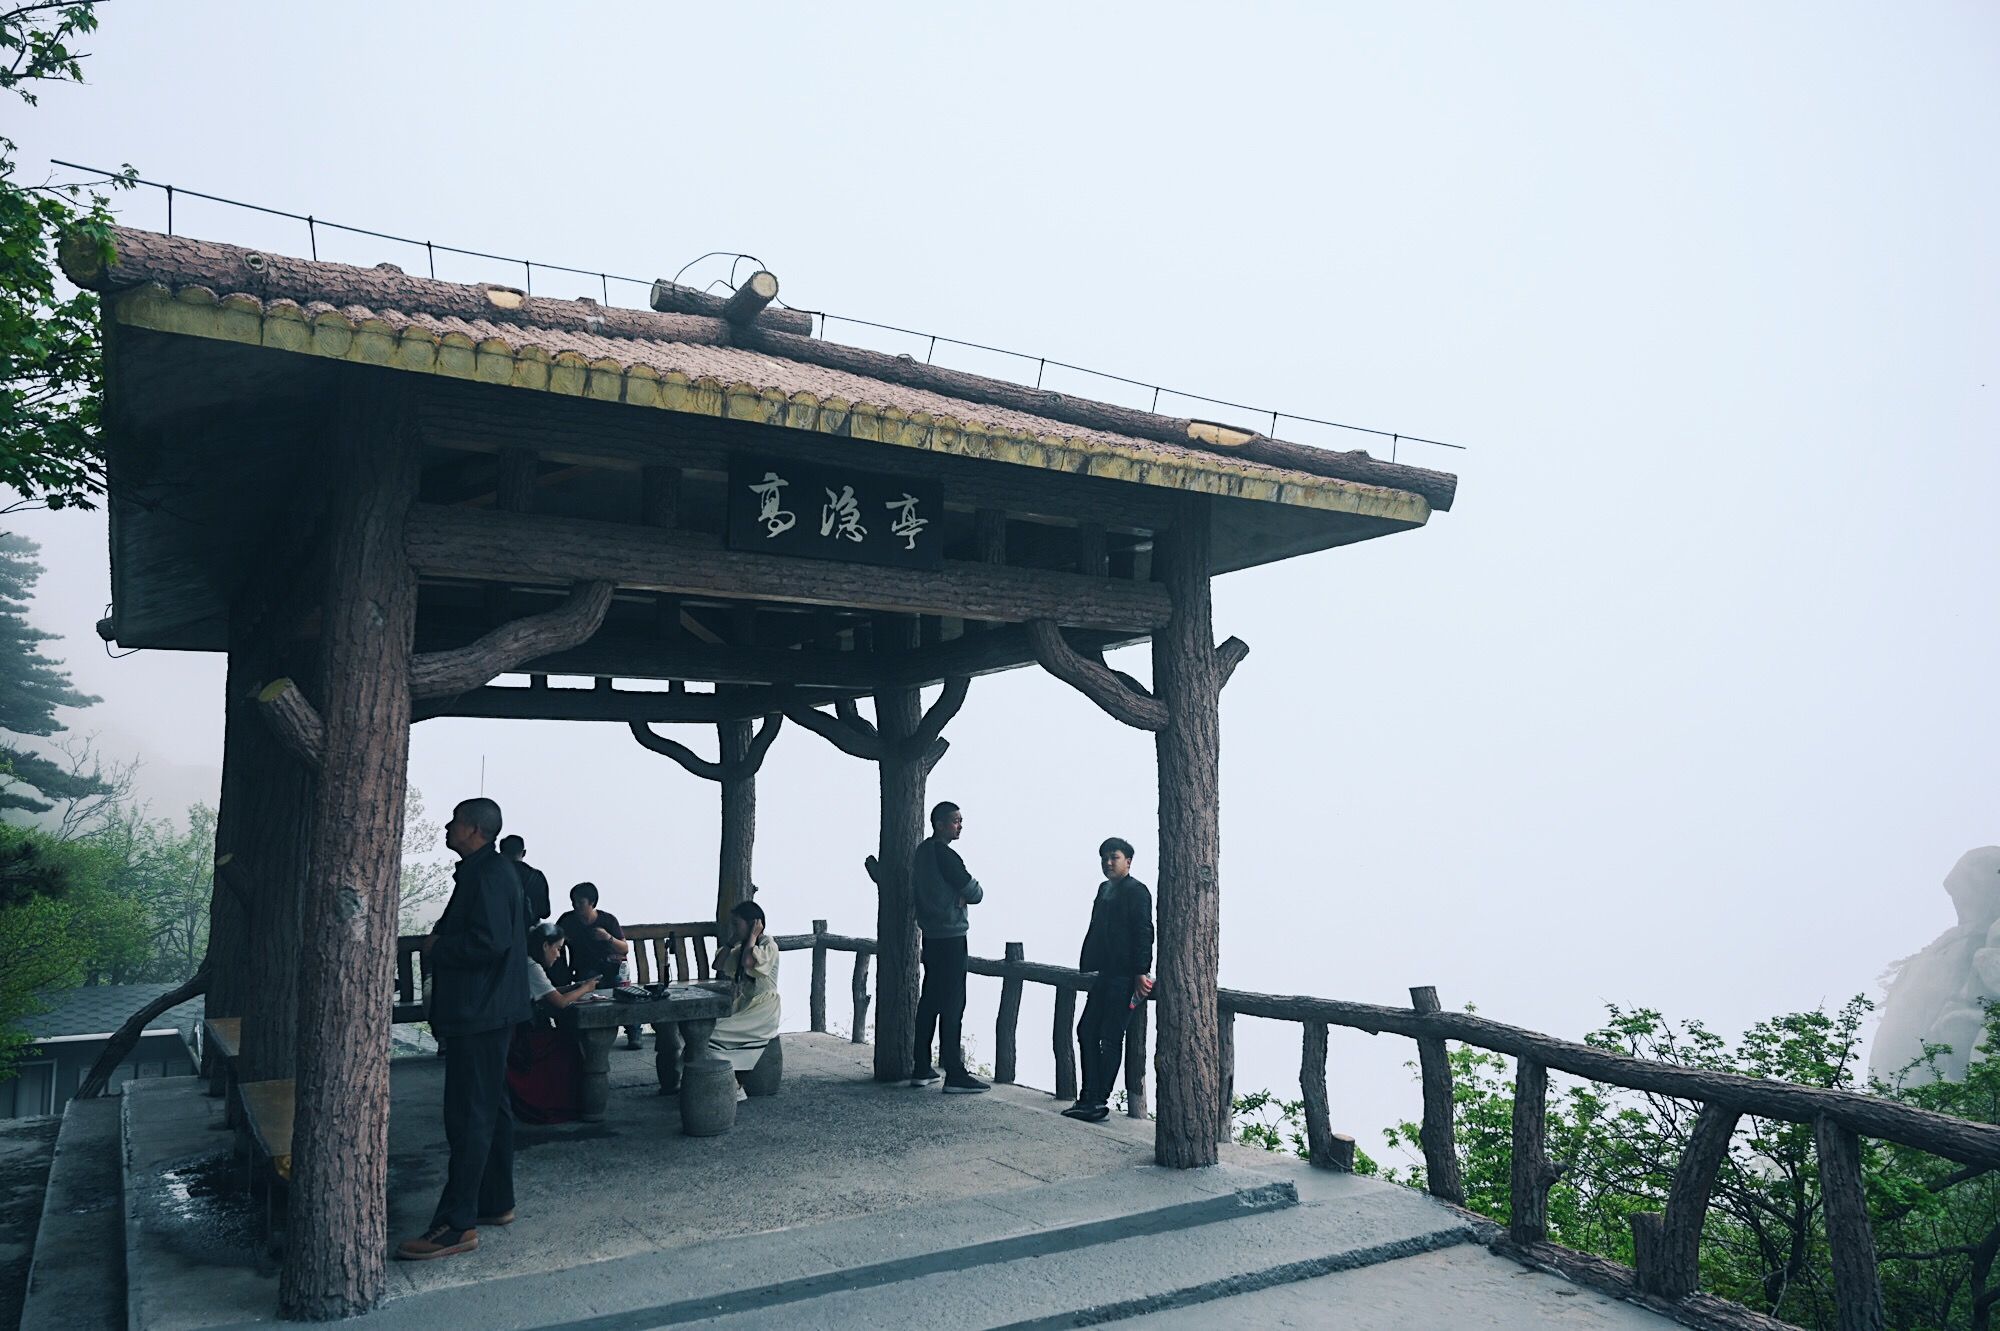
[426,845,528,1035]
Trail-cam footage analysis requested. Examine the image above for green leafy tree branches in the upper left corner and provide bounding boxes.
[0,2,132,508]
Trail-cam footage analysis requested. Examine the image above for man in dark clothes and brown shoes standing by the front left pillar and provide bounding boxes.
[396,799,528,1261]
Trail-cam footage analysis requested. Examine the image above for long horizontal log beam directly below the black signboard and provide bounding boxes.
[406,504,1172,630]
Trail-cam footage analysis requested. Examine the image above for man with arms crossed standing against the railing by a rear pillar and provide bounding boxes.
[910,801,992,1095]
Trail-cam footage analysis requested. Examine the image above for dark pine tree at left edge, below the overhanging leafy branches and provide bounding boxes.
[0,532,110,813]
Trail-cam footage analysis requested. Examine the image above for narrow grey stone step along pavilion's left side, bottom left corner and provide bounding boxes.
[20,1095,126,1331]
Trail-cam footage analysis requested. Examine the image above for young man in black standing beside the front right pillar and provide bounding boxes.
[1062,837,1152,1123]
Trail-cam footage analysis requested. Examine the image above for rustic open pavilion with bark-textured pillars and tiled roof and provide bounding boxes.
[64,230,1456,1317]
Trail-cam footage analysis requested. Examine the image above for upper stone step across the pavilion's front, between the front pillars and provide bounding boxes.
[356,1165,1298,1331]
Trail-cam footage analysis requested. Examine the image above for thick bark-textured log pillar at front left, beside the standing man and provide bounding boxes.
[278,383,418,1321]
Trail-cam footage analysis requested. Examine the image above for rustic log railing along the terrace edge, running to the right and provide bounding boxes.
[778,919,2000,1331]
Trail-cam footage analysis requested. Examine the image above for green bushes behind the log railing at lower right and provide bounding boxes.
[1384,997,2000,1331]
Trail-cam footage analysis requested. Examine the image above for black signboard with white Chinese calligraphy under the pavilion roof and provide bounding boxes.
[728,456,944,568]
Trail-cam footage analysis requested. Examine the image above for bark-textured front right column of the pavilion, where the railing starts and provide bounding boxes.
[1152,498,1222,1169]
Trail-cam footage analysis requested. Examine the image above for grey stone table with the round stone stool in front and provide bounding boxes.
[558,979,736,1137]
